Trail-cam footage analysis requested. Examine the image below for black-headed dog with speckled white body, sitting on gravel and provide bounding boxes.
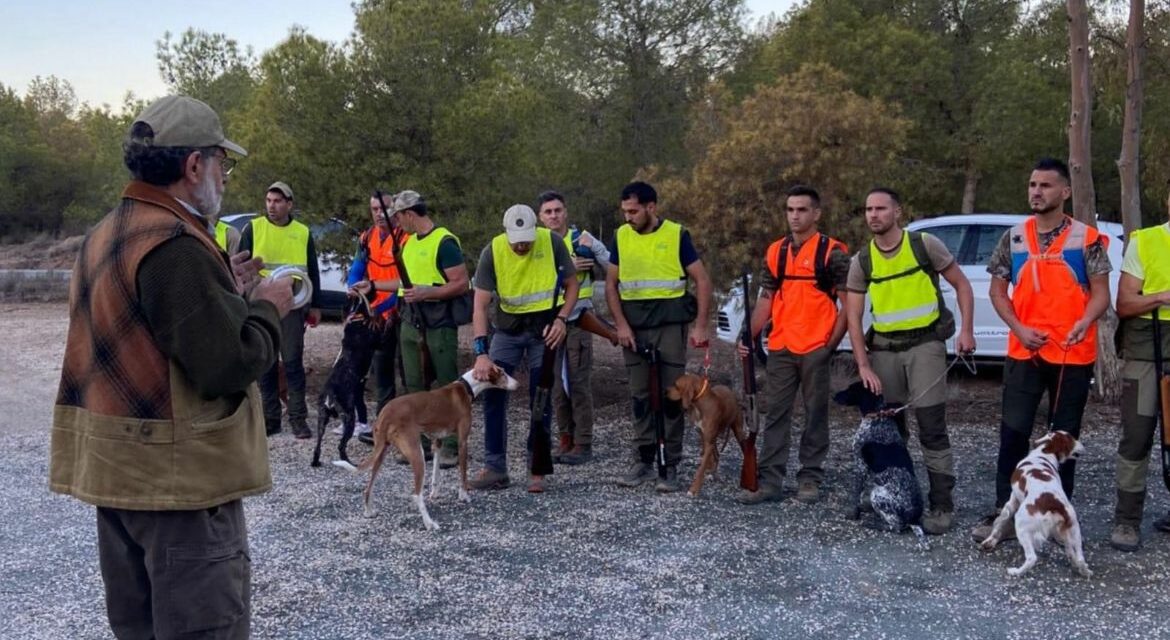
[835,381,929,549]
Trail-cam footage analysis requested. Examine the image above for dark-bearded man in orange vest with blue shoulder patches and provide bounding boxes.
[971,158,1113,543]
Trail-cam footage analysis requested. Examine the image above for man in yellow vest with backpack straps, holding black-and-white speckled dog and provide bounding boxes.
[846,187,975,535]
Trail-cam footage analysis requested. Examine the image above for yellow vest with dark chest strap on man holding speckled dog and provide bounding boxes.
[869,230,938,332]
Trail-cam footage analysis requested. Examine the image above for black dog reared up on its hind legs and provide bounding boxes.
[311,294,385,469]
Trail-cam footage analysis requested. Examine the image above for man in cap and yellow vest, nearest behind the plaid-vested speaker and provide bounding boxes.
[240,183,321,440]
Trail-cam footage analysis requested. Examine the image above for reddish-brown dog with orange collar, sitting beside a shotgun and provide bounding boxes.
[666,373,746,497]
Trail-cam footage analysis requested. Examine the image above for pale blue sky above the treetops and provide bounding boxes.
[0,0,796,109]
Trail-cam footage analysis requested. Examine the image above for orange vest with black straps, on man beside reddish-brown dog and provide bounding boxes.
[768,233,848,356]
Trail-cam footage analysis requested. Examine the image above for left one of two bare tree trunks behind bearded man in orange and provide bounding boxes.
[1068,0,1121,402]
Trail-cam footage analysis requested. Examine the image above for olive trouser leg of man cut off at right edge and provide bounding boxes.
[1114,360,1158,527]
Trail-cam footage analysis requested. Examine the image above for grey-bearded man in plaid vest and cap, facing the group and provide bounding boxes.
[49,96,293,639]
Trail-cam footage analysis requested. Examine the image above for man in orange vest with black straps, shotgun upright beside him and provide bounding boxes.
[737,186,849,504]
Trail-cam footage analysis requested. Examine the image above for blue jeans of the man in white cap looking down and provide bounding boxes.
[483,331,551,474]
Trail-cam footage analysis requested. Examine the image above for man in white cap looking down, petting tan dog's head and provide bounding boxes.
[472,205,580,494]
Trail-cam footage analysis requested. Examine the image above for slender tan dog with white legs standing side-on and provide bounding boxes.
[357,367,519,530]
